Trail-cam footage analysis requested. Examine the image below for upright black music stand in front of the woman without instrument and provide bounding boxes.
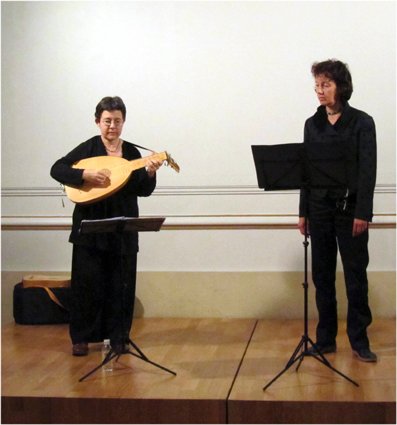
[252,142,359,391]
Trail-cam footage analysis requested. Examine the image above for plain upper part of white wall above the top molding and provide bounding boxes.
[1,1,396,187]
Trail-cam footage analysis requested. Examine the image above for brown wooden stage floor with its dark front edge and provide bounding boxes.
[2,318,396,424]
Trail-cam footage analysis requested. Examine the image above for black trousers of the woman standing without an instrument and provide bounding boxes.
[309,198,372,350]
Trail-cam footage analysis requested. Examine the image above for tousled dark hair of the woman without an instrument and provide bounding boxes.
[312,59,353,103]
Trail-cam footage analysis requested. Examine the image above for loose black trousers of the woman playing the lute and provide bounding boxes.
[69,244,137,344]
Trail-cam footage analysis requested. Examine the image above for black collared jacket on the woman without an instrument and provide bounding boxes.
[299,103,376,221]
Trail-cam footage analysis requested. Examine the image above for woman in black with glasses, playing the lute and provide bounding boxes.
[51,97,162,356]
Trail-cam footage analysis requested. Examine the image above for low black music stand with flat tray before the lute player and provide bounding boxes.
[79,217,176,382]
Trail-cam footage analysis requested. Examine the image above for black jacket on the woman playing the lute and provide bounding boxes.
[50,136,156,252]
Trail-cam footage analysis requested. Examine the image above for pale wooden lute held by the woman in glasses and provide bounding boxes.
[65,152,179,205]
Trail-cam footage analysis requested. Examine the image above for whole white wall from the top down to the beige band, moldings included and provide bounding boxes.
[1,1,396,271]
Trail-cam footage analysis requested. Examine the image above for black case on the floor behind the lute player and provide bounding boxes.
[13,282,70,325]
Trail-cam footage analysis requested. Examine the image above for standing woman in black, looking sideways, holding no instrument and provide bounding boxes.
[298,60,377,362]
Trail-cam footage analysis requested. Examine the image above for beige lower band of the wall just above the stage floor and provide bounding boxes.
[2,270,396,323]
